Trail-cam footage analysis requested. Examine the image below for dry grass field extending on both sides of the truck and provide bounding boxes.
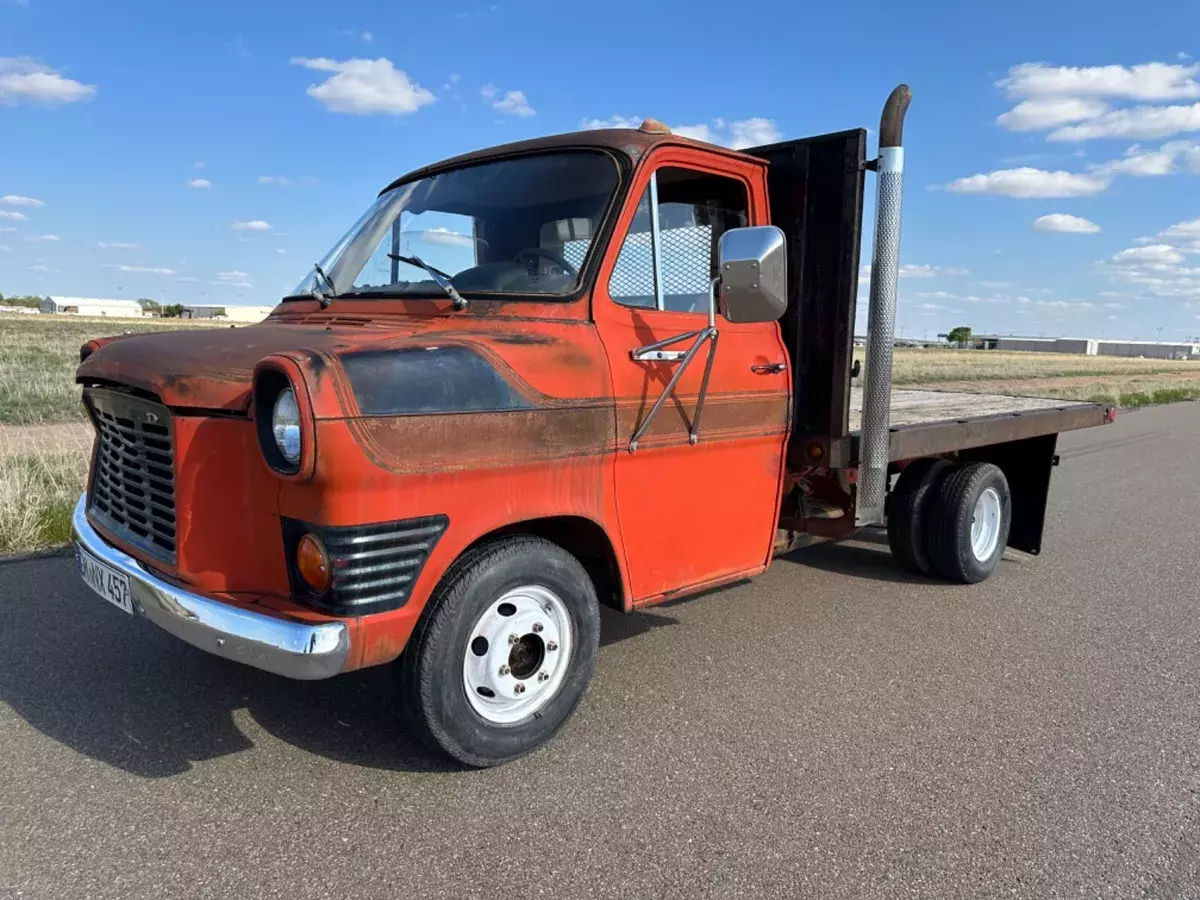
[0,314,1200,553]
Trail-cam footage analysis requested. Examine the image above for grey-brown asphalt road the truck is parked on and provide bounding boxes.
[0,404,1200,900]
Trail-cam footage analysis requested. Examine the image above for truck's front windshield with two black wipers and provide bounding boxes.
[292,151,617,296]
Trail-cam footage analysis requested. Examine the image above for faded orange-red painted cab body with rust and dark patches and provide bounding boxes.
[78,132,791,668]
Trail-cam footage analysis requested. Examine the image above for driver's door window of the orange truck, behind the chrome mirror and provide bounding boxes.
[608,167,749,313]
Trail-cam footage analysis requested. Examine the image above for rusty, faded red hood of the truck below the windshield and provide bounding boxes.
[76,318,439,412]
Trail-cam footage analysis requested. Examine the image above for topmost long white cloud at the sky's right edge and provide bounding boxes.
[996,62,1200,100]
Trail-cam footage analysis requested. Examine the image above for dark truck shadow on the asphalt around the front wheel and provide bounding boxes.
[0,558,673,779]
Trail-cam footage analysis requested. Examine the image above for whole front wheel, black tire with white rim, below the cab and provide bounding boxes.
[398,536,600,767]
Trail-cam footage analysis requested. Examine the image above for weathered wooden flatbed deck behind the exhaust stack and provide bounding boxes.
[850,386,1111,460]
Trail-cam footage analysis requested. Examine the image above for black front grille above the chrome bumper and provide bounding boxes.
[85,389,175,563]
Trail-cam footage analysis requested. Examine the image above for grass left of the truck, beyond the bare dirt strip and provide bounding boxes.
[0,314,228,425]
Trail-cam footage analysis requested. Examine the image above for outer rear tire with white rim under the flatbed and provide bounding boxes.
[929,462,1013,584]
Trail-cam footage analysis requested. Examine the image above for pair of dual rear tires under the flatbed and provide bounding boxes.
[888,460,1012,584]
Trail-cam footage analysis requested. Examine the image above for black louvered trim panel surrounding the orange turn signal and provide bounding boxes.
[283,516,450,616]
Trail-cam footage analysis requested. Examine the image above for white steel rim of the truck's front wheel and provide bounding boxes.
[462,584,575,725]
